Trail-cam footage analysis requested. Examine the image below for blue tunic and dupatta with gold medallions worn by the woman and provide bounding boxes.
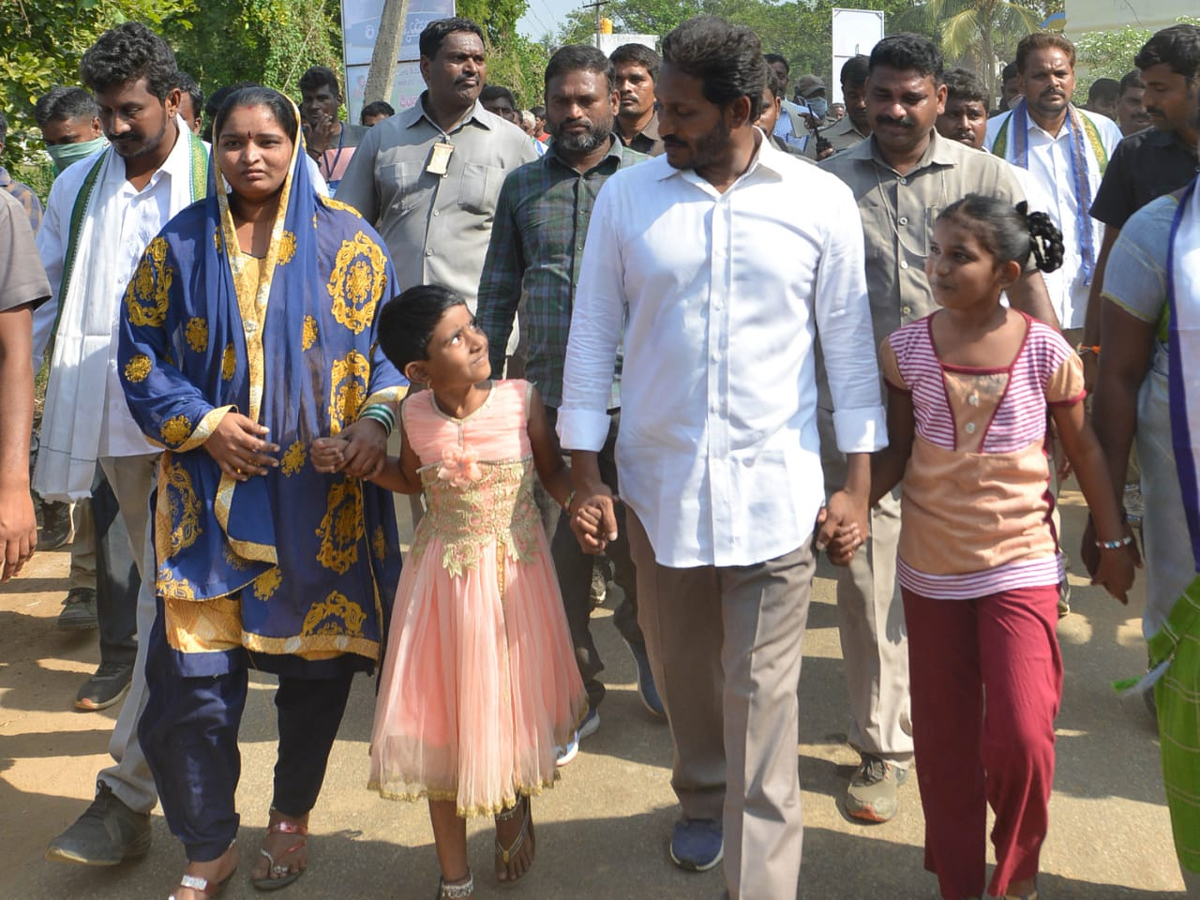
[118,111,407,670]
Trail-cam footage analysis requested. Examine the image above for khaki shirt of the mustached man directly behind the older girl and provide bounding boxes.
[820,132,1025,347]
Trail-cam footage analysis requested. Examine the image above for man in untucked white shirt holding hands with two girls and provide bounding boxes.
[558,17,886,900]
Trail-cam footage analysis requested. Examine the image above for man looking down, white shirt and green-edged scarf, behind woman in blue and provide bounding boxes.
[34,23,208,865]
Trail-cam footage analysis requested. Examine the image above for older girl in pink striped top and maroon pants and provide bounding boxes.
[840,194,1138,900]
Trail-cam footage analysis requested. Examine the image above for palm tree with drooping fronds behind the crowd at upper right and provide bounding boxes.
[902,0,1043,106]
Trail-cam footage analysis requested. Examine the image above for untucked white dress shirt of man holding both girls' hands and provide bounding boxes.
[558,142,887,568]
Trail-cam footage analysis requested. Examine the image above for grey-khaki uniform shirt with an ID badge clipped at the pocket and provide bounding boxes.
[337,94,538,312]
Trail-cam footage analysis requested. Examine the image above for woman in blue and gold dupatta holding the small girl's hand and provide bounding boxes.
[118,86,406,900]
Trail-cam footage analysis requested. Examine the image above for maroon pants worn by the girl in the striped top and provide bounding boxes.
[902,586,1062,900]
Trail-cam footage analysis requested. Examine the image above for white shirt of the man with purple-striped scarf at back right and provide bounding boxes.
[985,109,1121,328]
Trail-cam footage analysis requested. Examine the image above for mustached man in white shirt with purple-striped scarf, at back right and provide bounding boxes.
[986,31,1121,344]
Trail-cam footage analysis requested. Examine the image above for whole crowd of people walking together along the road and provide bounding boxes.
[0,10,1200,900]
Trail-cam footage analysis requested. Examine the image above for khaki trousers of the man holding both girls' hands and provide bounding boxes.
[625,509,814,900]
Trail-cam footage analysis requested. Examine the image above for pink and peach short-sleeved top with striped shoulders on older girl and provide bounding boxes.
[880,313,1085,599]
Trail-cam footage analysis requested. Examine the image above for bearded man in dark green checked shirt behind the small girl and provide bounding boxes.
[479,46,662,748]
